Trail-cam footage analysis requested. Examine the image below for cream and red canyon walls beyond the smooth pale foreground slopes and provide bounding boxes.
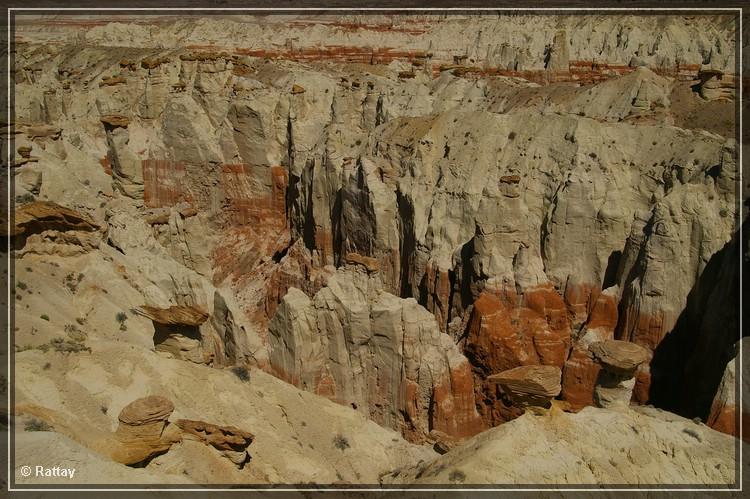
[12,10,743,464]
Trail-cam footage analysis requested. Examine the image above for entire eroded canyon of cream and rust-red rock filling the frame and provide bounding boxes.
[4,12,750,487]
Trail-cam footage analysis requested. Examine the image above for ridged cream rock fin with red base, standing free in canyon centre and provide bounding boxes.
[269,271,483,441]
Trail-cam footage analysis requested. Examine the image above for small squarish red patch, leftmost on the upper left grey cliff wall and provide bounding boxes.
[142,159,193,208]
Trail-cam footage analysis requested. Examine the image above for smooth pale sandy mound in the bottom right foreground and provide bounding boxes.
[383,407,735,487]
